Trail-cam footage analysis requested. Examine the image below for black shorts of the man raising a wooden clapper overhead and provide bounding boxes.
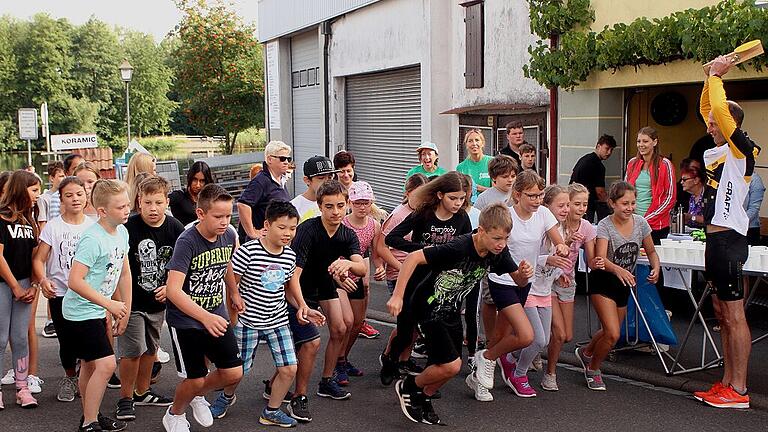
[704,230,749,301]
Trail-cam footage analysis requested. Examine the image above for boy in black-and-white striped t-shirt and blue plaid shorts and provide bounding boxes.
[214,201,325,427]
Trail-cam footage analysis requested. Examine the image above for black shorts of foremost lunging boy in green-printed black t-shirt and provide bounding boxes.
[420,313,464,365]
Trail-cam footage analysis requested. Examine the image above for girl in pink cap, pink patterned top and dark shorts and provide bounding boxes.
[335,181,386,386]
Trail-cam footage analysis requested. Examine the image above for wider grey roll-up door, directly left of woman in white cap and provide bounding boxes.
[346,66,421,210]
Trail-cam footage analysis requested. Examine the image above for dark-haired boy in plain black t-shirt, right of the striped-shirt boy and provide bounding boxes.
[290,180,367,400]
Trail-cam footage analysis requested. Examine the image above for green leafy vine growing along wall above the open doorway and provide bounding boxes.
[523,0,768,90]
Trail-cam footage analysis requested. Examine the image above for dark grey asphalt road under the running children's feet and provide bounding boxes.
[0,323,768,432]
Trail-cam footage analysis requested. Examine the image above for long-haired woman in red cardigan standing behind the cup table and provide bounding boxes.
[626,126,677,244]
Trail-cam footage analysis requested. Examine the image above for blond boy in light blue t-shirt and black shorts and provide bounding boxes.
[62,180,131,432]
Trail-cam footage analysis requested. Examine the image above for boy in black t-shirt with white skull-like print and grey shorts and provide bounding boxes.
[115,176,184,420]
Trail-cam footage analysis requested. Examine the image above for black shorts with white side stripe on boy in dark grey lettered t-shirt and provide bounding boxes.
[170,325,243,379]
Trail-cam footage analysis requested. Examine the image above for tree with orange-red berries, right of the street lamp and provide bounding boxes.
[173,0,264,154]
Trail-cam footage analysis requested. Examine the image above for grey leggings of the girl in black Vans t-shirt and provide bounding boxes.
[0,279,32,388]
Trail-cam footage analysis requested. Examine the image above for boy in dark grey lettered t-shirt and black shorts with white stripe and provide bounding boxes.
[163,184,243,432]
